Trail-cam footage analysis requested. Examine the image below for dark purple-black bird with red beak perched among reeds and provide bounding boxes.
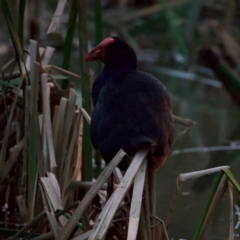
[85,37,174,170]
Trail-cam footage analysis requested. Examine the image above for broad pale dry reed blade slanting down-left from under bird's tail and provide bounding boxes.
[89,149,149,240]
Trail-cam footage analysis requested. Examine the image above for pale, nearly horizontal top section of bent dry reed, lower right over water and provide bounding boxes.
[179,166,230,182]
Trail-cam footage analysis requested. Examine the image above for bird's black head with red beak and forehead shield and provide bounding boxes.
[85,37,137,70]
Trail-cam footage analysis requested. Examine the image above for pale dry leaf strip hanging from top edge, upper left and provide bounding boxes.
[47,0,67,34]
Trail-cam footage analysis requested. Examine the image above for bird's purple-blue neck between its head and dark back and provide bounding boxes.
[92,65,136,106]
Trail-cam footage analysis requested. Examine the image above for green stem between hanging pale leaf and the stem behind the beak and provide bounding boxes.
[61,0,77,89]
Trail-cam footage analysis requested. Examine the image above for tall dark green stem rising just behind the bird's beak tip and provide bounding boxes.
[78,0,92,181]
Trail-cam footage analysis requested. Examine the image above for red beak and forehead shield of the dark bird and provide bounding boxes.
[85,37,114,62]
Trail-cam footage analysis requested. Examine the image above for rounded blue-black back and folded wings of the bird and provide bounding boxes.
[91,72,173,166]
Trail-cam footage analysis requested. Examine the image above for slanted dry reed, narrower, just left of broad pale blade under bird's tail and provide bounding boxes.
[58,149,126,240]
